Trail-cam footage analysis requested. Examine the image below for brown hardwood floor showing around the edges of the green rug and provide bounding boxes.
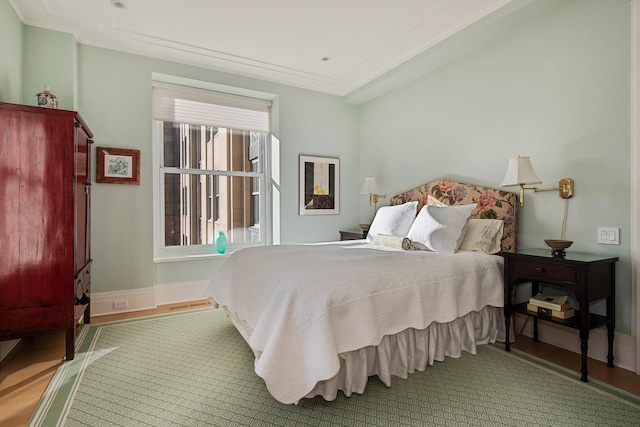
[0,300,640,427]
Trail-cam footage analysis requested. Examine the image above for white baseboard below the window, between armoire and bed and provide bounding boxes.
[91,280,208,317]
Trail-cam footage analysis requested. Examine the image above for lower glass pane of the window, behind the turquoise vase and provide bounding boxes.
[164,173,262,246]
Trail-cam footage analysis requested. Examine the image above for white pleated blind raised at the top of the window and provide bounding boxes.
[153,82,271,132]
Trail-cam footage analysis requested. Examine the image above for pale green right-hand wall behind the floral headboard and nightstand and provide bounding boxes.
[359,0,632,334]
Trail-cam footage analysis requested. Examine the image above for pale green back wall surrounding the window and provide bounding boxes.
[17,26,359,293]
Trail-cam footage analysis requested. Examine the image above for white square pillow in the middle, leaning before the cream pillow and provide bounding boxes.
[407,204,476,254]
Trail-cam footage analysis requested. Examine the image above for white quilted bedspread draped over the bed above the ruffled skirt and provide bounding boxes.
[205,241,503,403]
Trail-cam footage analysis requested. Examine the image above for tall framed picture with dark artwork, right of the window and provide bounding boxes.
[300,155,340,215]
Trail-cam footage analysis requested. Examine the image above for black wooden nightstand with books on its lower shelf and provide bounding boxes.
[503,249,618,381]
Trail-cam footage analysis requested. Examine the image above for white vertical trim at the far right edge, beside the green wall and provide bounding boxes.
[631,0,640,374]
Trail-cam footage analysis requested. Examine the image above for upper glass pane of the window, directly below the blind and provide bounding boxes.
[163,122,267,172]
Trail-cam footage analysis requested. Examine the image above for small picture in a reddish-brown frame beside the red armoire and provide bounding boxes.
[96,147,140,184]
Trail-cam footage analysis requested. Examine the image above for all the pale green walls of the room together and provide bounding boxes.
[0,0,632,334]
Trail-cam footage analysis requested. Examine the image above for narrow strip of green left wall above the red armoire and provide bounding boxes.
[0,0,21,103]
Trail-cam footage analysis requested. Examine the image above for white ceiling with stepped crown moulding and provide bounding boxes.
[9,0,516,95]
